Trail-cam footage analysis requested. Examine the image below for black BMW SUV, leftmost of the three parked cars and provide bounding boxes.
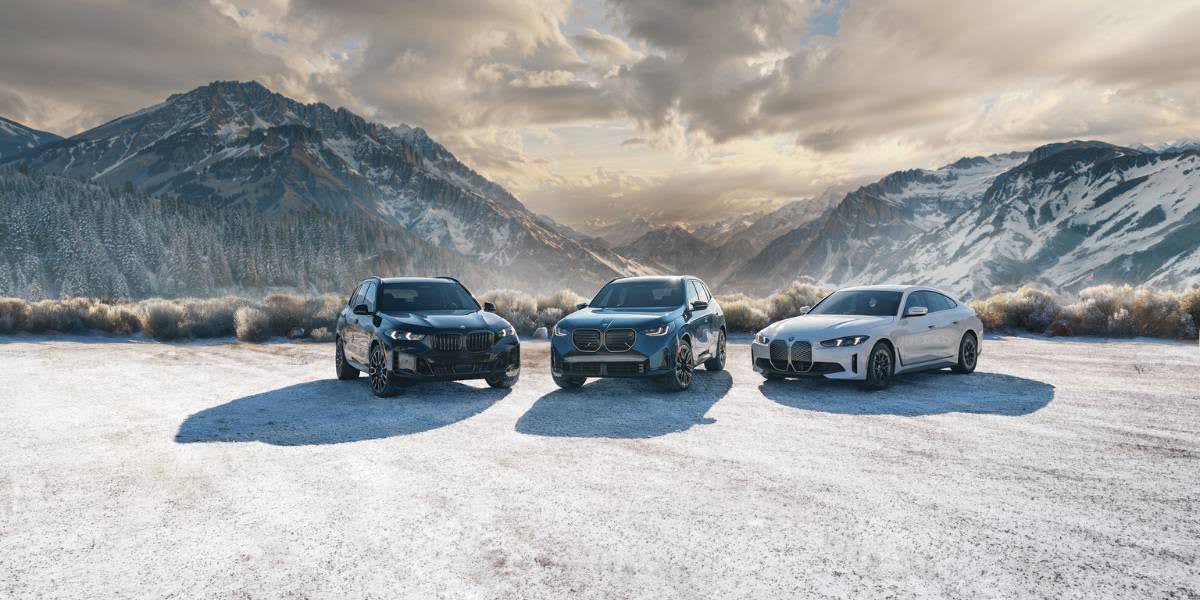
[335,277,521,396]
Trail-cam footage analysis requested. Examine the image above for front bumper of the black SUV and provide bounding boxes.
[386,336,521,382]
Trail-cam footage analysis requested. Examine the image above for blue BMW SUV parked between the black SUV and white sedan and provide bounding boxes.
[550,277,725,390]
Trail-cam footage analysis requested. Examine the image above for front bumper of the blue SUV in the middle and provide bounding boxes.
[550,335,676,377]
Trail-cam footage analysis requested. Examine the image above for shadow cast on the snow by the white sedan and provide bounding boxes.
[758,371,1054,416]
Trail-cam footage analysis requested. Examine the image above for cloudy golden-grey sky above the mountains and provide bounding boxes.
[0,0,1200,223]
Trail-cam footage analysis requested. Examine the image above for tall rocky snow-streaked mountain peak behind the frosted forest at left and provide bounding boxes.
[9,82,644,289]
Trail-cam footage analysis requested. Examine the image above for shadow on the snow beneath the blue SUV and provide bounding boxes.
[516,371,733,438]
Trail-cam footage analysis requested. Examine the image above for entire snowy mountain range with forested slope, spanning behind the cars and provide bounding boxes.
[0,82,1200,296]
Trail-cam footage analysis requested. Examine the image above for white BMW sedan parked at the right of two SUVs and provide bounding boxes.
[750,286,983,389]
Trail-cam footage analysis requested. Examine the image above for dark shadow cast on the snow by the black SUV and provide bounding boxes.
[175,378,509,446]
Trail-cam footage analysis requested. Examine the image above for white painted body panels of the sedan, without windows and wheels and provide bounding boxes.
[750,286,983,380]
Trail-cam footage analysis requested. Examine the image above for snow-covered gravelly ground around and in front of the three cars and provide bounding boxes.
[0,337,1200,599]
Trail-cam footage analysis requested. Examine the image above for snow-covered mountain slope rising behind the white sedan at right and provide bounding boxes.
[730,142,1200,296]
